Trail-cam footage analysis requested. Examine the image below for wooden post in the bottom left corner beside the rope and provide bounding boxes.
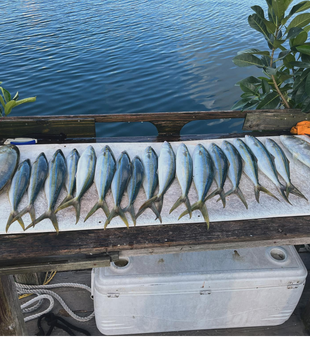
[0,276,28,339]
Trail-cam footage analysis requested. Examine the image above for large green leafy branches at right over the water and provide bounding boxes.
[232,0,310,112]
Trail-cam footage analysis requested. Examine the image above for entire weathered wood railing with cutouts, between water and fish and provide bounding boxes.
[0,110,310,139]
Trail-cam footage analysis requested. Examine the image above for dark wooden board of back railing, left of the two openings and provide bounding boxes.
[0,117,96,140]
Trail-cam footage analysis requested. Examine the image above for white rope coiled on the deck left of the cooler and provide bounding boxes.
[16,283,95,322]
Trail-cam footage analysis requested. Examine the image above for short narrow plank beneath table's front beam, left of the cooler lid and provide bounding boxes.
[0,253,118,274]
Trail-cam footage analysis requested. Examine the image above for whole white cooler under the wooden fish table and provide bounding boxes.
[92,246,307,336]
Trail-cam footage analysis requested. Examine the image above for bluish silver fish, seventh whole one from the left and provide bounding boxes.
[104,151,132,229]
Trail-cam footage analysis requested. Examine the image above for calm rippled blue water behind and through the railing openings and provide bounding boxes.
[0,0,266,136]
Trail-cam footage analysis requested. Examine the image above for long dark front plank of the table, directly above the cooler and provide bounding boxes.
[0,216,310,266]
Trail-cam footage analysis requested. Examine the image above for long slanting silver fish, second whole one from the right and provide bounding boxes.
[245,136,290,203]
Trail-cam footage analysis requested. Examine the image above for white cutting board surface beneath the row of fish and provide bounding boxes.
[0,137,310,234]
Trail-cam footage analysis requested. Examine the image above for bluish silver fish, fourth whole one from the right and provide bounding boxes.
[222,141,248,209]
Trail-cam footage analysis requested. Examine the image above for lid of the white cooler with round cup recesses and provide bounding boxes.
[94,246,307,290]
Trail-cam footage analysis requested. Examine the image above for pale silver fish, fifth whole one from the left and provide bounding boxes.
[55,146,96,224]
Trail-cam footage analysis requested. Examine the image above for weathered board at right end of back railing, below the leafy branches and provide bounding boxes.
[243,110,310,132]
